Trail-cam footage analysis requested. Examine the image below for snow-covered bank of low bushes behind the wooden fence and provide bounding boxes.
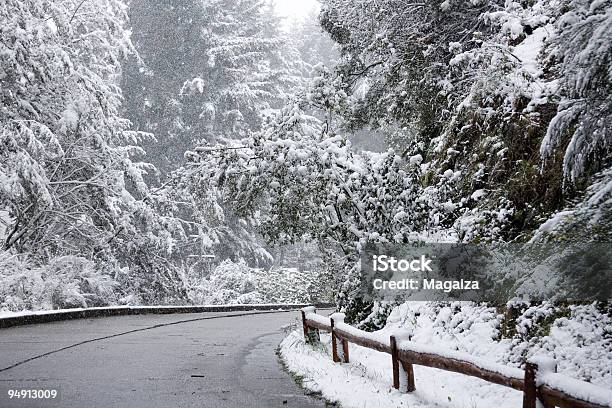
[383,302,612,388]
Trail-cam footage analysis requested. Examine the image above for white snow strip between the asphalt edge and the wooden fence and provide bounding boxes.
[280,331,522,408]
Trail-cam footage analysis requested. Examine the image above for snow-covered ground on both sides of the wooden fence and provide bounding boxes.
[280,302,612,408]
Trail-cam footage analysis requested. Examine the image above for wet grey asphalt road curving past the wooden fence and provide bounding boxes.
[0,311,325,408]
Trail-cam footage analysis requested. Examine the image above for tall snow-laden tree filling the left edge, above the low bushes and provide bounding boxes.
[0,0,191,301]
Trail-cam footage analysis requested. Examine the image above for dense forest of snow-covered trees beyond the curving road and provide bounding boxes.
[0,0,612,318]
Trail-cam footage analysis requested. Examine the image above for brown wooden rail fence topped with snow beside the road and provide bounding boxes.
[301,307,612,408]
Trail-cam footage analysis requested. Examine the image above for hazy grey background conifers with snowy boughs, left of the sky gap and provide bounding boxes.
[123,0,300,178]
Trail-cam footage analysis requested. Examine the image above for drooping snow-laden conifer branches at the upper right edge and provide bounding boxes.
[540,0,612,187]
